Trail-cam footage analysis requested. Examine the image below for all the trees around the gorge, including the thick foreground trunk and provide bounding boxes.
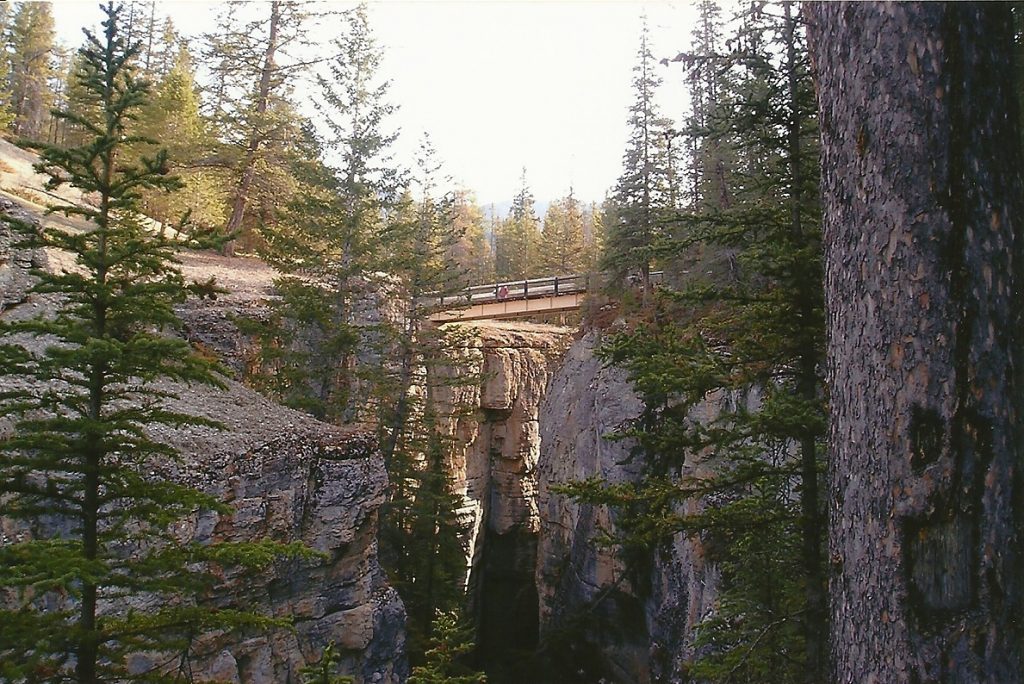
[0,0,1024,682]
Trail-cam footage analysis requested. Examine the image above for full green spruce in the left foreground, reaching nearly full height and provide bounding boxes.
[0,3,299,683]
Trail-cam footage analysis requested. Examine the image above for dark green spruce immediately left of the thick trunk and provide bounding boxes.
[583,3,827,682]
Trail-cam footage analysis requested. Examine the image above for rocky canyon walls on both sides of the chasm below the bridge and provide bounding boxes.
[0,193,716,683]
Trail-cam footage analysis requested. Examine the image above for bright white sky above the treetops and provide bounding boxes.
[53,0,695,205]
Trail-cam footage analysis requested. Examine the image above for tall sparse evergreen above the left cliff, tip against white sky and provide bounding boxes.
[249,7,400,422]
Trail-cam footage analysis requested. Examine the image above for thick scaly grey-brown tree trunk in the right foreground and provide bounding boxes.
[807,2,1024,684]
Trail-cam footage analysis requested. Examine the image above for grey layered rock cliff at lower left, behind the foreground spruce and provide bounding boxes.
[0,201,408,684]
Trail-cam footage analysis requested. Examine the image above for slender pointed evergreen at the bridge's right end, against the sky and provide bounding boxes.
[602,22,674,303]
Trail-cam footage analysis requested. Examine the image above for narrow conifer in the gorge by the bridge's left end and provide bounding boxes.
[374,140,479,658]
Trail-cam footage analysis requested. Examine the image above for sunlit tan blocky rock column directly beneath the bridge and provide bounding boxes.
[430,322,571,660]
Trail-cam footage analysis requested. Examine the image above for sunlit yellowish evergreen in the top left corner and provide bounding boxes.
[9,2,54,140]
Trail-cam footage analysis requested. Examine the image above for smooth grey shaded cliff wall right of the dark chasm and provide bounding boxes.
[537,333,715,682]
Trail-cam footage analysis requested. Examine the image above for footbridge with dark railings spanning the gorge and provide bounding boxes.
[430,271,663,323]
